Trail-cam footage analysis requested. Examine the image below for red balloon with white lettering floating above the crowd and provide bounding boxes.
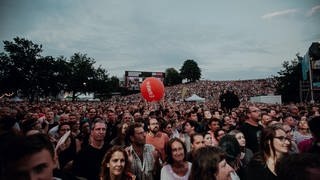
[140,77,164,102]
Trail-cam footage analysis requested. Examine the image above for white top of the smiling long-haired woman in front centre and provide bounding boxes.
[160,162,192,180]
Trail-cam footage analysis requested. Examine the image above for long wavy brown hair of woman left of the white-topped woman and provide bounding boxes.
[100,146,130,180]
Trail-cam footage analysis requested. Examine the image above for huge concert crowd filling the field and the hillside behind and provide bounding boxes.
[0,79,320,180]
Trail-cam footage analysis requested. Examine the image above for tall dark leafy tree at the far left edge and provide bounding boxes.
[0,37,43,101]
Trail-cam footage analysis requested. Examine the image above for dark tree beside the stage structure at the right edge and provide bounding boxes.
[275,55,302,103]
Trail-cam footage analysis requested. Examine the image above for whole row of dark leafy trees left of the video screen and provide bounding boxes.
[0,37,119,101]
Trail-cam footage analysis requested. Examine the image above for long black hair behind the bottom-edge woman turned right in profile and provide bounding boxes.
[219,134,241,168]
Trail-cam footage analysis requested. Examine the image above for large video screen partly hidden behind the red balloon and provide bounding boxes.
[125,71,165,91]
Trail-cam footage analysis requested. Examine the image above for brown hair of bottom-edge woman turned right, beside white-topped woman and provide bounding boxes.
[189,146,225,180]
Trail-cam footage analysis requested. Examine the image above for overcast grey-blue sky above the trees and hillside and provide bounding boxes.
[0,0,320,80]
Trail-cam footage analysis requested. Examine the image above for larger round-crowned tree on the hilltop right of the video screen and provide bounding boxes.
[180,59,201,82]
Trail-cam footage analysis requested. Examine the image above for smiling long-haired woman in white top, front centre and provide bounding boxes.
[161,138,191,180]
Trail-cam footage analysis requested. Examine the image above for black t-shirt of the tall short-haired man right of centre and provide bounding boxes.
[240,123,263,153]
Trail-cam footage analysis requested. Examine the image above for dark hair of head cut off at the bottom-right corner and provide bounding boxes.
[275,153,320,180]
